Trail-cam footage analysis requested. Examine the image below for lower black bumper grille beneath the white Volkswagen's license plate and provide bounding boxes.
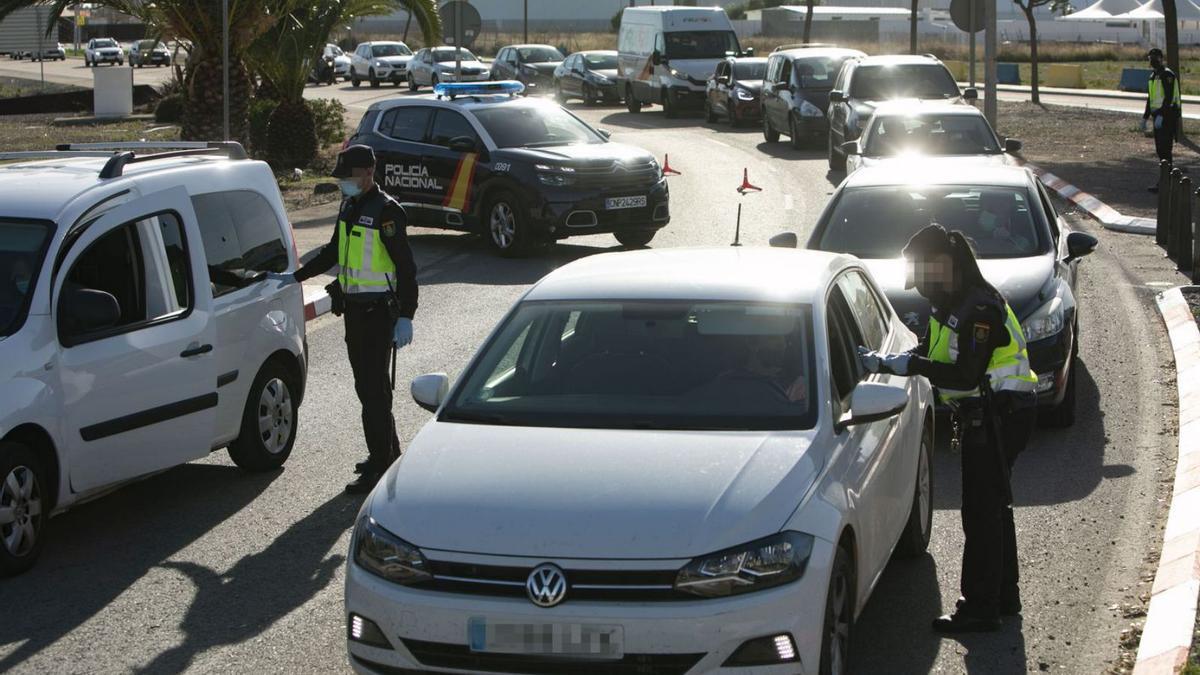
[401,638,704,675]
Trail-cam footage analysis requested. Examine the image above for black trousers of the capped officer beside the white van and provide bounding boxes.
[344,303,400,473]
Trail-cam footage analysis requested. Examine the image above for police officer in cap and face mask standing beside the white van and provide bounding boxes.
[295,145,418,494]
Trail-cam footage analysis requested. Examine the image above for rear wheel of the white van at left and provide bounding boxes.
[229,360,300,471]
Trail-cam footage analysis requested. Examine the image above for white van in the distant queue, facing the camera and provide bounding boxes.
[617,7,754,118]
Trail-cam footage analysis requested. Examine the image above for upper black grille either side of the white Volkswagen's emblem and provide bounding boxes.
[413,560,696,603]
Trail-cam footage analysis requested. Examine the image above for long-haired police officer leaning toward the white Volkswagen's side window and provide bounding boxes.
[860,225,1037,633]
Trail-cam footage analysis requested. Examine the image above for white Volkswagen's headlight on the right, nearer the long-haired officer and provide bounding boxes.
[674,532,812,598]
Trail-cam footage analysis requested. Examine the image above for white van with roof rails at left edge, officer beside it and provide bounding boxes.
[0,143,307,577]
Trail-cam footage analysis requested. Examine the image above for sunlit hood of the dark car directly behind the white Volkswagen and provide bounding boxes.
[864,253,1057,335]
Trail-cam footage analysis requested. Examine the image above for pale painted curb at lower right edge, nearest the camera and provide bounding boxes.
[1133,286,1200,675]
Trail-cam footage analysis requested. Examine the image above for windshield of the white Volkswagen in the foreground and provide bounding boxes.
[440,300,817,430]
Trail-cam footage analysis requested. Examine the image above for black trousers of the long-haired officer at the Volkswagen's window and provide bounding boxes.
[958,396,1037,617]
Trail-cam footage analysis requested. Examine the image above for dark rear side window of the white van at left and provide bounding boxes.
[192,190,288,297]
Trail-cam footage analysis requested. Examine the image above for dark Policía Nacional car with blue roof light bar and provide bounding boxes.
[347,82,671,256]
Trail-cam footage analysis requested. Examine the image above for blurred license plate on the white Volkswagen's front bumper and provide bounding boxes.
[467,616,625,659]
